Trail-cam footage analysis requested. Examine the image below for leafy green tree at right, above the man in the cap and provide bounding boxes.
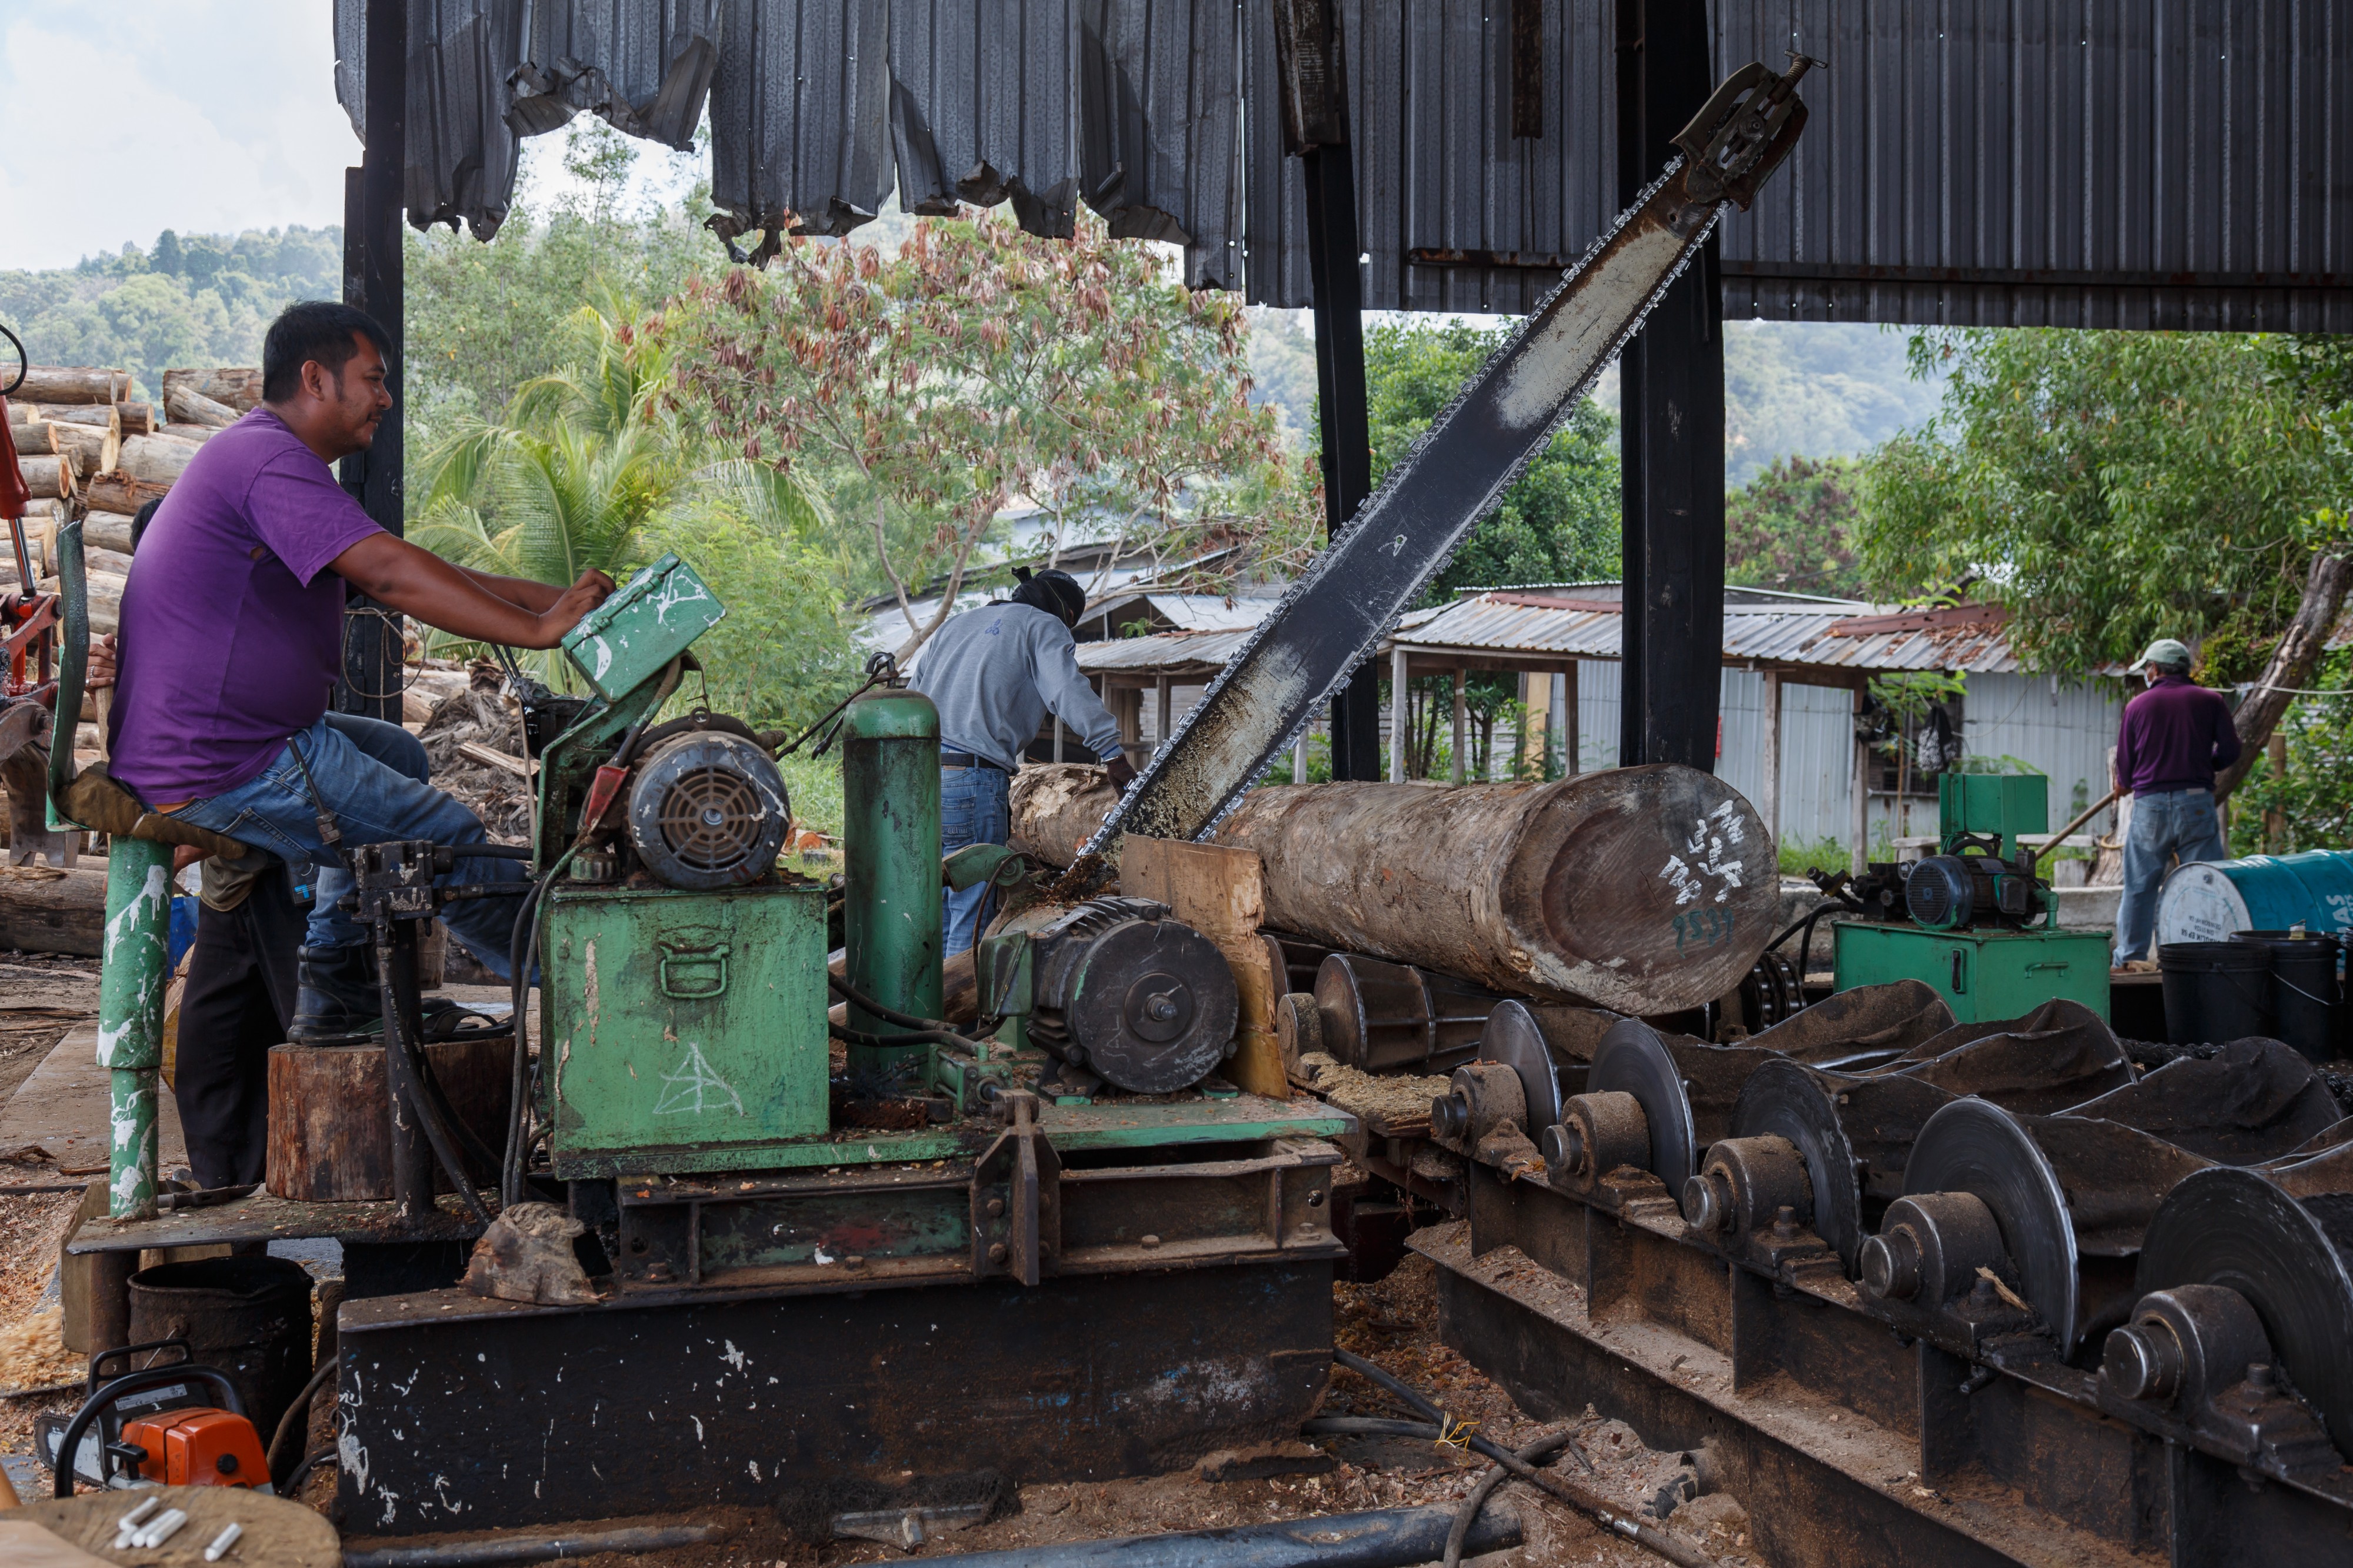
[1859,327,2348,673]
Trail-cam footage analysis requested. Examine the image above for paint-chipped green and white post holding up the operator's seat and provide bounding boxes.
[99,836,172,1220]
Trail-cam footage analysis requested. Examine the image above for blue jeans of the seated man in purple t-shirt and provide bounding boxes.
[174,716,527,979]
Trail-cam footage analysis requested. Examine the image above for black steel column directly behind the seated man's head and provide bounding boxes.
[334,0,409,723]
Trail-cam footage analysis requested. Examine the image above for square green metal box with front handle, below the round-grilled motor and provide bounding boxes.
[539,883,831,1180]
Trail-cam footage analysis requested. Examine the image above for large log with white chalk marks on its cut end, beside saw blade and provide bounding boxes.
[1195,765,1781,1015]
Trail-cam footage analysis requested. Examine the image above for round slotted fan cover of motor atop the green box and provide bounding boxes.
[628,730,793,892]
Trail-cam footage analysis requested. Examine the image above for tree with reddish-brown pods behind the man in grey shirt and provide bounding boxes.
[647,214,1306,657]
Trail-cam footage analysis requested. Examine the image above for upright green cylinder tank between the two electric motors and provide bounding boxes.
[842,688,944,1073]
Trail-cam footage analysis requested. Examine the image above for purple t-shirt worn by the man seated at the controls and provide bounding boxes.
[111,408,381,805]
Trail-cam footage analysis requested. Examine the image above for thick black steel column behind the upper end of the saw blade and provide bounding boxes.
[1619,0,1725,772]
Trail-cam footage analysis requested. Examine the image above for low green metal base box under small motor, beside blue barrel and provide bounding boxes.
[1831,920,2113,1024]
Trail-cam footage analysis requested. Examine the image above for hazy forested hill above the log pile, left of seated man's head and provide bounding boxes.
[0,223,344,398]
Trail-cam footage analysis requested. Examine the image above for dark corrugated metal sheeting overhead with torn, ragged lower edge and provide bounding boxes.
[362,0,2353,332]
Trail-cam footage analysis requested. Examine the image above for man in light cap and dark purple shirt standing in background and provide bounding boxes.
[2115,638,2238,968]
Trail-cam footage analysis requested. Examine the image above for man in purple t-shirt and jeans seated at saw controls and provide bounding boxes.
[111,301,612,1040]
